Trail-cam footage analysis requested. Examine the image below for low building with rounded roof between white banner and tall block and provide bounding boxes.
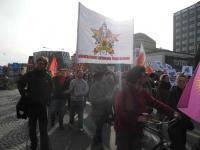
[134,33,194,71]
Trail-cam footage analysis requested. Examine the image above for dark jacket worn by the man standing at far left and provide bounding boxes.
[17,70,52,105]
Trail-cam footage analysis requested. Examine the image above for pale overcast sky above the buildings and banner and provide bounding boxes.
[0,0,198,65]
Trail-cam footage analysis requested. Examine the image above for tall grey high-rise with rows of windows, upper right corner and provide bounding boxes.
[173,2,200,54]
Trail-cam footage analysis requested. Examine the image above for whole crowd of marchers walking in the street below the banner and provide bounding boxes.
[18,57,194,150]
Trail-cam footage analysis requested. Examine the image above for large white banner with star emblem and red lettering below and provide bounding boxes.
[77,3,134,64]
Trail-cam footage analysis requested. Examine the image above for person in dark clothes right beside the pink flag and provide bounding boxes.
[168,74,194,150]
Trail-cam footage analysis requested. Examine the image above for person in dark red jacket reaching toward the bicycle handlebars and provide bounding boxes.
[114,66,179,150]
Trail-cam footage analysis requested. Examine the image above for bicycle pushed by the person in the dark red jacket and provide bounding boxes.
[142,114,176,150]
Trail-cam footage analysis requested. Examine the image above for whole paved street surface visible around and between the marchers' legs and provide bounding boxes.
[0,90,200,150]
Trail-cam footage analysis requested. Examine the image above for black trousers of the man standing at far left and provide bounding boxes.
[28,104,49,150]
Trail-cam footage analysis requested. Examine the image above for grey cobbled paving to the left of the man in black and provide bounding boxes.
[0,90,28,150]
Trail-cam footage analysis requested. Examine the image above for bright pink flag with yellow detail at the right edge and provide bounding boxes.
[177,64,200,122]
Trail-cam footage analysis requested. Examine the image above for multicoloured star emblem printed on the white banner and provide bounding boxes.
[91,22,119,54]
